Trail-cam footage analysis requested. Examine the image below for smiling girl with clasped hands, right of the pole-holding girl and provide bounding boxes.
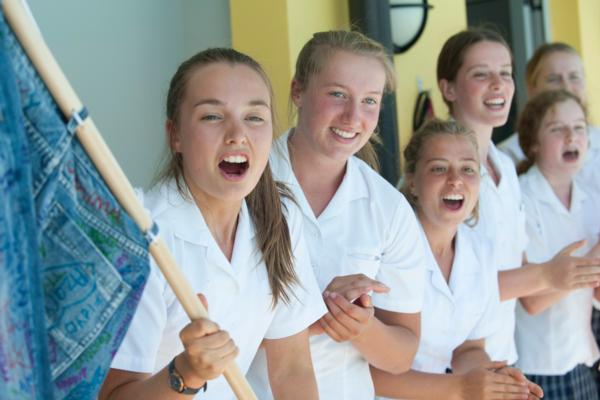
[247,31,425,400]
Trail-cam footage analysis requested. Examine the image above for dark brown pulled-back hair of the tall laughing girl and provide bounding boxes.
[437,27,512,113]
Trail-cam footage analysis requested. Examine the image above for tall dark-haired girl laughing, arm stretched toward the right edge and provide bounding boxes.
[437,29,600,364]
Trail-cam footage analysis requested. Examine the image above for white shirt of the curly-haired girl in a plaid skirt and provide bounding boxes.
[516,166,600,375]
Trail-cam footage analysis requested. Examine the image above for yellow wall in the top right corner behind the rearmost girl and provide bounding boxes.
[549,0,600,125]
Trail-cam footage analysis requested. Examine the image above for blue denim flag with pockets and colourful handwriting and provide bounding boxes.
[0,5,149,399]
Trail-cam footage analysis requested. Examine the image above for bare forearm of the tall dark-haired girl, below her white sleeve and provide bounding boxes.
[498,264,549,301]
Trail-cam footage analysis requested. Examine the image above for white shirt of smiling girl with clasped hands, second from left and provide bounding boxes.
[251,132,426,400]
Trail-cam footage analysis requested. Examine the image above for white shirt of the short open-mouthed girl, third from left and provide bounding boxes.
[412,225,500,374]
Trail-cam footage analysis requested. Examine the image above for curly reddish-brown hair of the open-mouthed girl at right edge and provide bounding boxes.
[517,89,587,175]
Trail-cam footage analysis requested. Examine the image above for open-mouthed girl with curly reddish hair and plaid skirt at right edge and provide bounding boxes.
[516,90,600,400]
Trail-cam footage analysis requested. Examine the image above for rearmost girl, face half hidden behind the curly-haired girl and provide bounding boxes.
[498,42,600,164]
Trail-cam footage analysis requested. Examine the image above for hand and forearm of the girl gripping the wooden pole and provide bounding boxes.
[98,295,238,400]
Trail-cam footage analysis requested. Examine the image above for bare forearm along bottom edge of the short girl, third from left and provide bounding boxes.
[371,367,460,400]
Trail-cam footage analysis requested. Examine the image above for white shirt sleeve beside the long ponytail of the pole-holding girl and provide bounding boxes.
[265,202,327,339]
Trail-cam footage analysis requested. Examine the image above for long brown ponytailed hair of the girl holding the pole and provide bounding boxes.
[155,48,298,306]
